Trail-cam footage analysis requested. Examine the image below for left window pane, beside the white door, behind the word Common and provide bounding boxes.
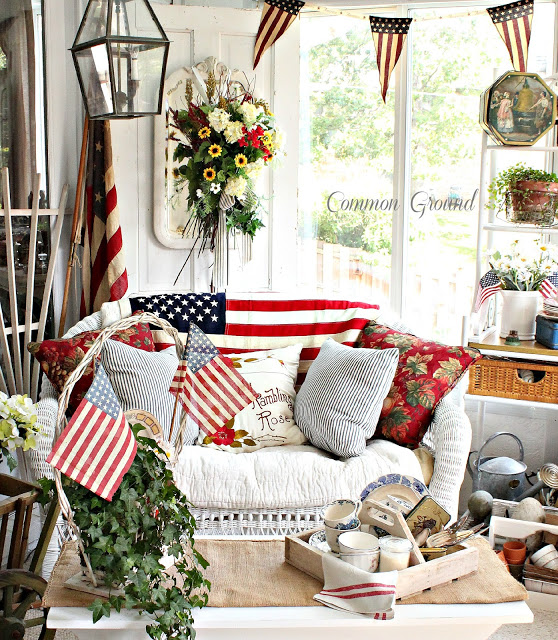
[297,17,399,304]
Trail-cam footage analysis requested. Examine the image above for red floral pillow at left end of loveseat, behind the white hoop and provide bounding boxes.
[27,322,155,411]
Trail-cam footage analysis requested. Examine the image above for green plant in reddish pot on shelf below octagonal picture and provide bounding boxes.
[487,162,558,226]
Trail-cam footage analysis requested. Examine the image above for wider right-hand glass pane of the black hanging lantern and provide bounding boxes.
[111,42,165,116]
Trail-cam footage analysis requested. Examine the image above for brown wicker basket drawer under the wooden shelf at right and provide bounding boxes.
[469,358,558,403]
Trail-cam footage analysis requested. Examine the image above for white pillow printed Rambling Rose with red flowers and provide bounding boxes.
[198,344,306,453]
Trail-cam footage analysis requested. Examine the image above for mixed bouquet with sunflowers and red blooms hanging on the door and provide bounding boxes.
[171,73,281,250]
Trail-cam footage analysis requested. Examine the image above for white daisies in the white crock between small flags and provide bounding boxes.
[489,239,557,291]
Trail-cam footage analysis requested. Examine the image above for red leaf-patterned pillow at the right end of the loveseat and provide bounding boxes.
[357,322,481,448]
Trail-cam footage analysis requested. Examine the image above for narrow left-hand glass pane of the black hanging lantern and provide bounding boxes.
[75,44,113,118]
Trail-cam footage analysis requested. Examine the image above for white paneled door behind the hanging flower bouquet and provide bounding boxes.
[113,4,299,292]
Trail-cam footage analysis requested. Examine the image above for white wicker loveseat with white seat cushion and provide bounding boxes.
[32,300,471,535]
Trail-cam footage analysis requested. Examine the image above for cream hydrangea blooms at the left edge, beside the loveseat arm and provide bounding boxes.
[0,391,41,471]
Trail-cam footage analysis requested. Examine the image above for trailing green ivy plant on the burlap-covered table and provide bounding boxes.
[40,425,210,640]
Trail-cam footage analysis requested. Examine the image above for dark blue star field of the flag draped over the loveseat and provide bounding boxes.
[129,293,227,349]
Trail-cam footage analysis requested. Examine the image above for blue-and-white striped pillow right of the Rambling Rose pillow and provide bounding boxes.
[294,339,399,458]
